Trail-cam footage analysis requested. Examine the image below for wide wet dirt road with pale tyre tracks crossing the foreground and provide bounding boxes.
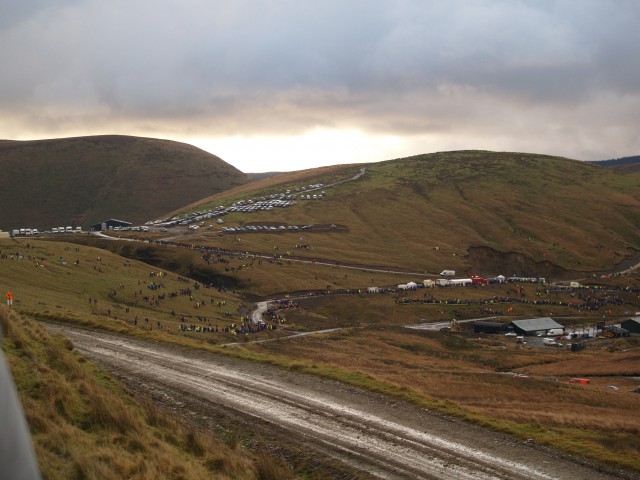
[48,325,632,480]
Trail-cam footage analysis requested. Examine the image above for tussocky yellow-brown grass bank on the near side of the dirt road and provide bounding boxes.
[0,306,291,480]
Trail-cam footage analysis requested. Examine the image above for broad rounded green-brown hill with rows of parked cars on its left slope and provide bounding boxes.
[174,151,640,277]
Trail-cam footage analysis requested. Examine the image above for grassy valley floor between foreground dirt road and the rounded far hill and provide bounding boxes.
[0,235,640,470]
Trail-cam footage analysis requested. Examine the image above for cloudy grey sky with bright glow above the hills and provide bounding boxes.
[0,0,640,172]
